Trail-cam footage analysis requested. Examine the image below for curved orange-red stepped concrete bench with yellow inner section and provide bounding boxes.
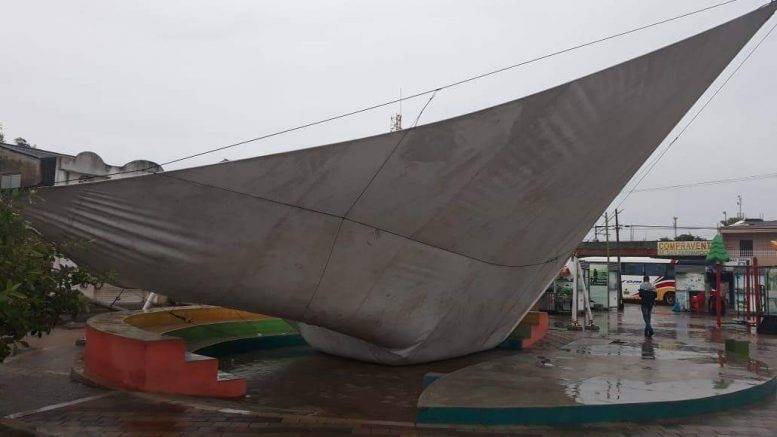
[79,306,298,398]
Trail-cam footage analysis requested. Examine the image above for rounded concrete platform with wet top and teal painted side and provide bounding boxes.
[417,326,777,425]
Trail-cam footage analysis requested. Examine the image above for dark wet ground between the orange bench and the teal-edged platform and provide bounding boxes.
[224,346,514,421]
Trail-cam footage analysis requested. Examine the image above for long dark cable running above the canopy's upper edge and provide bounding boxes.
[47,0,739,185]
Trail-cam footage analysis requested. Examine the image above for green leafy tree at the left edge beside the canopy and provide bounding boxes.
[0,191,100,361]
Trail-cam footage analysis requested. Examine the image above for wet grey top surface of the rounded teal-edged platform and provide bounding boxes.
[419,338,773,408]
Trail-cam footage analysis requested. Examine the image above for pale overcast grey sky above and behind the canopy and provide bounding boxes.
[0,0,777,239]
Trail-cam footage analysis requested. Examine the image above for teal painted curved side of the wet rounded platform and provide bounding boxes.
[416,378,777,425]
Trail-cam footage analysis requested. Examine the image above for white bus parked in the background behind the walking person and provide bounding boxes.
[580,256,677,305]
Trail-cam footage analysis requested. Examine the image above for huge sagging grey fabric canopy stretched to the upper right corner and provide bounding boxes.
[26,4,775,364]
